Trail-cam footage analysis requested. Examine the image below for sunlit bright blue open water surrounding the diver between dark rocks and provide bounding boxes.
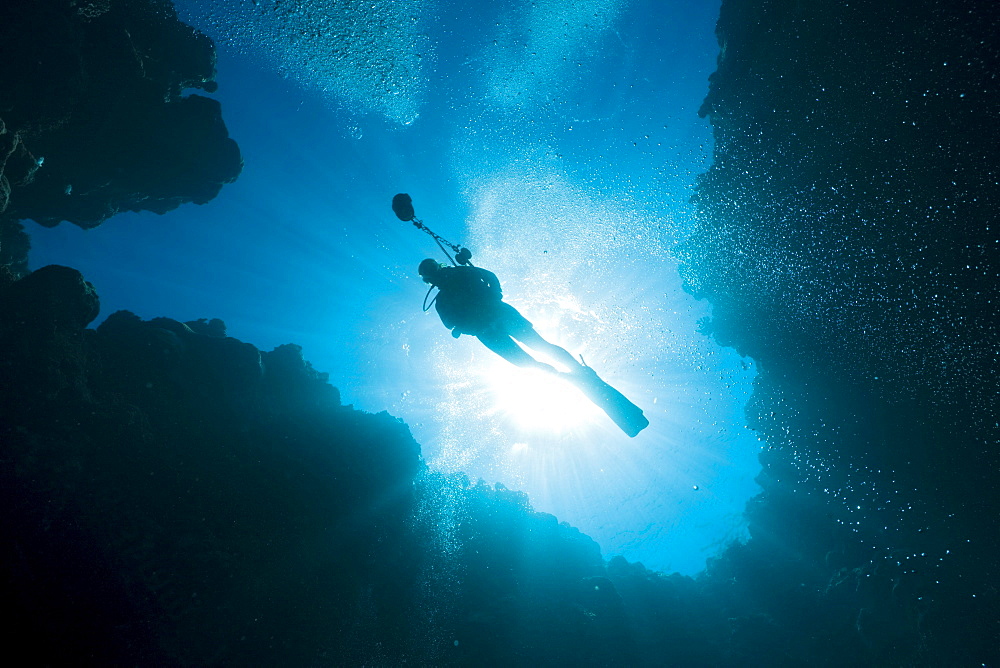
[29,0,759,573]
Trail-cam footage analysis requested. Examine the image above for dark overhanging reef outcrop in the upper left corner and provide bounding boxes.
[0,0,242,272]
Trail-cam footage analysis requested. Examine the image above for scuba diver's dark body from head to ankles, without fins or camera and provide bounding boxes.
[418,258,588,373]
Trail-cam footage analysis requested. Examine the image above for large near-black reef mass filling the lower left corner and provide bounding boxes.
[0,266,420,665]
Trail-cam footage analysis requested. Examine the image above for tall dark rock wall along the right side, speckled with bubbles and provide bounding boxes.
[682,0,1000,665]
